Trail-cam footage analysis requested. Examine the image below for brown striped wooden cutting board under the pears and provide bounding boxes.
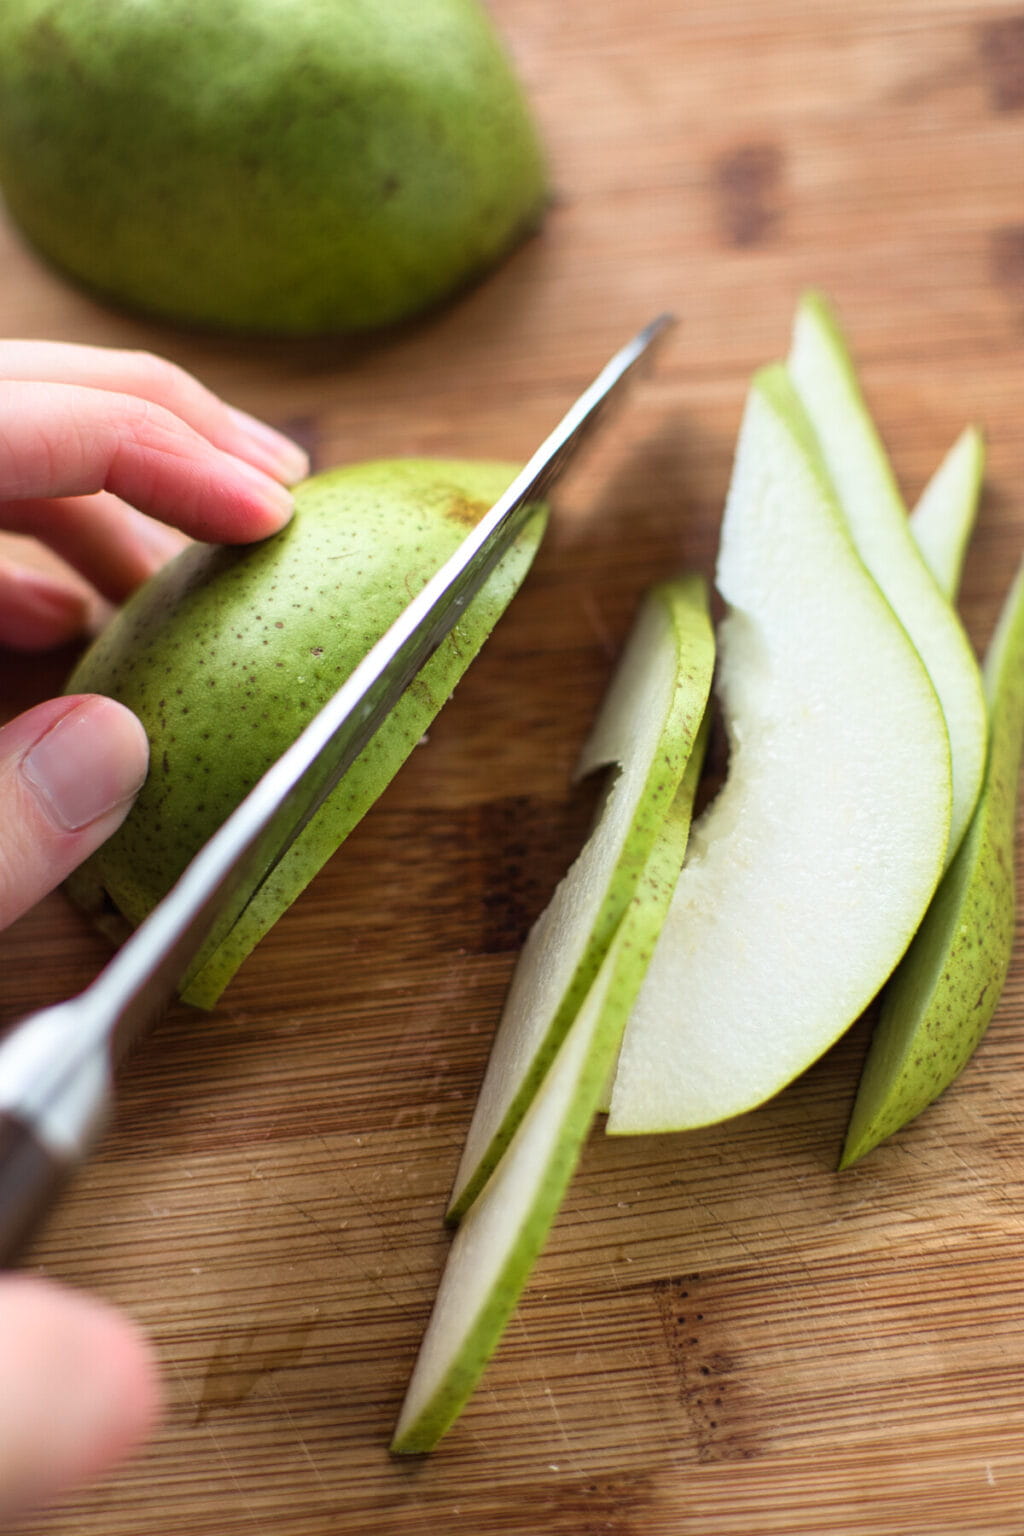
[0,0,1024,1536]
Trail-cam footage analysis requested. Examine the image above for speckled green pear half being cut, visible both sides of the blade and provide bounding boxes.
[68,459,543,1008]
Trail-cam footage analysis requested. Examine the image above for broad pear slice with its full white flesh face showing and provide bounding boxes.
[608,366,950,1134]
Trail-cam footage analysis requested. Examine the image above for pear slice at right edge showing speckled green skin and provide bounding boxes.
[840,564,1024,1167]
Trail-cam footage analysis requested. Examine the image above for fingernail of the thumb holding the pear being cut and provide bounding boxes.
[21,697,147,833]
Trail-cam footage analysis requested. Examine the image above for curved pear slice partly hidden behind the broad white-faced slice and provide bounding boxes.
[789,293,987,865]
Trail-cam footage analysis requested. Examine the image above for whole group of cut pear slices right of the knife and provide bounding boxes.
[393,295,1024,1453]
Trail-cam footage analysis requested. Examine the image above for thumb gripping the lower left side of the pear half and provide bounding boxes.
[0,694,149,928]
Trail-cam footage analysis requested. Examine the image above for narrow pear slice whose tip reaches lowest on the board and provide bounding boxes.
[391,716,706,1453]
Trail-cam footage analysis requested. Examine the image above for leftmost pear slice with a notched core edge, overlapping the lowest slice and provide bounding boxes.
[448,576,714,1218]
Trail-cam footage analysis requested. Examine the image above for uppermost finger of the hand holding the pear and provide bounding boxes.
[0,341,309,485]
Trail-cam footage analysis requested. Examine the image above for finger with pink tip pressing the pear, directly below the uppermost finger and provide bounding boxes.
[0,381,292,542]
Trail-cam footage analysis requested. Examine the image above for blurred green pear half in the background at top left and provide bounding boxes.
[0,0,547,335]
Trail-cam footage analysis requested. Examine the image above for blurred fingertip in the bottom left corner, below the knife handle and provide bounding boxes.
[0,1275,160,1530]
